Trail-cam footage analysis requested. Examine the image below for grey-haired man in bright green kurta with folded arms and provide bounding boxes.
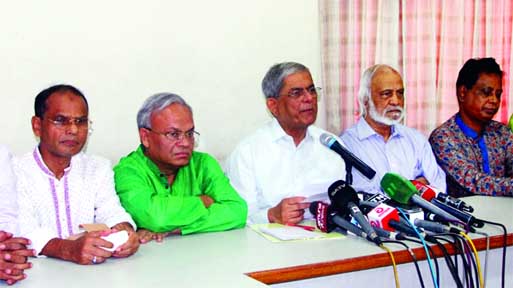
[114,93,247,243]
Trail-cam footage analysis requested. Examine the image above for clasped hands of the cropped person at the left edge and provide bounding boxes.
[0,231,35,285]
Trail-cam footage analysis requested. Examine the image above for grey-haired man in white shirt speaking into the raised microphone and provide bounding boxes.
[226,62,345,224]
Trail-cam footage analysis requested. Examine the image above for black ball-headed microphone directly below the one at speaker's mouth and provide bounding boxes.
[328,180,381,245]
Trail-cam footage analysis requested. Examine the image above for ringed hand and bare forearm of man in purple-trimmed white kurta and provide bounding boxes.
[41,230,112,265]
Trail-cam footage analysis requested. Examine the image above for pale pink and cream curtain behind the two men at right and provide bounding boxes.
[319,0,513,136]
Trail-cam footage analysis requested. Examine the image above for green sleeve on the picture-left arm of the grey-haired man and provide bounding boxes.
[114,154,208,232]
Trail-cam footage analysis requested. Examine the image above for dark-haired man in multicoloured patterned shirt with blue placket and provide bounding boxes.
[429,58,513,197]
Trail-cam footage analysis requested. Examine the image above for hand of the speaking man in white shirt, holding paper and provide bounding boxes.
[267,196,310,224]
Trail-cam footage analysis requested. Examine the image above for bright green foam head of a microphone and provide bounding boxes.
[380,173,417,204]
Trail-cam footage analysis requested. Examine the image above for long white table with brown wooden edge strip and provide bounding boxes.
[11,196,513,288]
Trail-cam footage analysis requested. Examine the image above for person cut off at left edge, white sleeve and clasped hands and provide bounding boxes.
[0,145,35,285]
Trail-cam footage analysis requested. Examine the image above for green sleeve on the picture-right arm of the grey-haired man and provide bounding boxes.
[182,154,248,234]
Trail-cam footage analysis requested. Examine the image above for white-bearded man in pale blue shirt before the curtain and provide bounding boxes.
[341,64,446,194]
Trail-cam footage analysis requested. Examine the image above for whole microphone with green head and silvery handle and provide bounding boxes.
[380,173,460,222]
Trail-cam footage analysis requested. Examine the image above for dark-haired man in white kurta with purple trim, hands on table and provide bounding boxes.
[15,85,139,264]
